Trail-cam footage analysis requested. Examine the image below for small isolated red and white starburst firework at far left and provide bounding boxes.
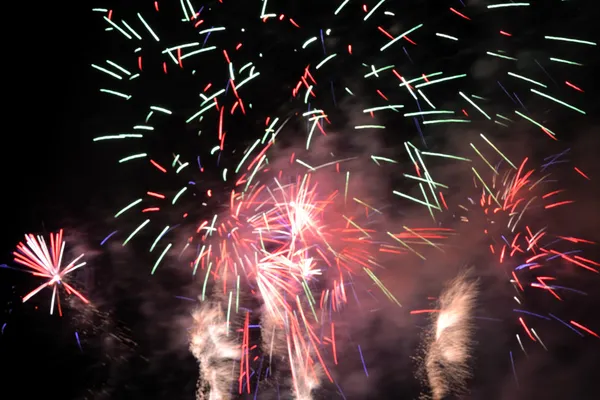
[13,229,89,315]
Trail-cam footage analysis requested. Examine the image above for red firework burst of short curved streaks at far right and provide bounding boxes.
[460,150,600,360]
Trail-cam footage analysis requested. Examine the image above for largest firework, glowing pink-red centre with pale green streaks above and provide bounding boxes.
[92,1,596,398]
